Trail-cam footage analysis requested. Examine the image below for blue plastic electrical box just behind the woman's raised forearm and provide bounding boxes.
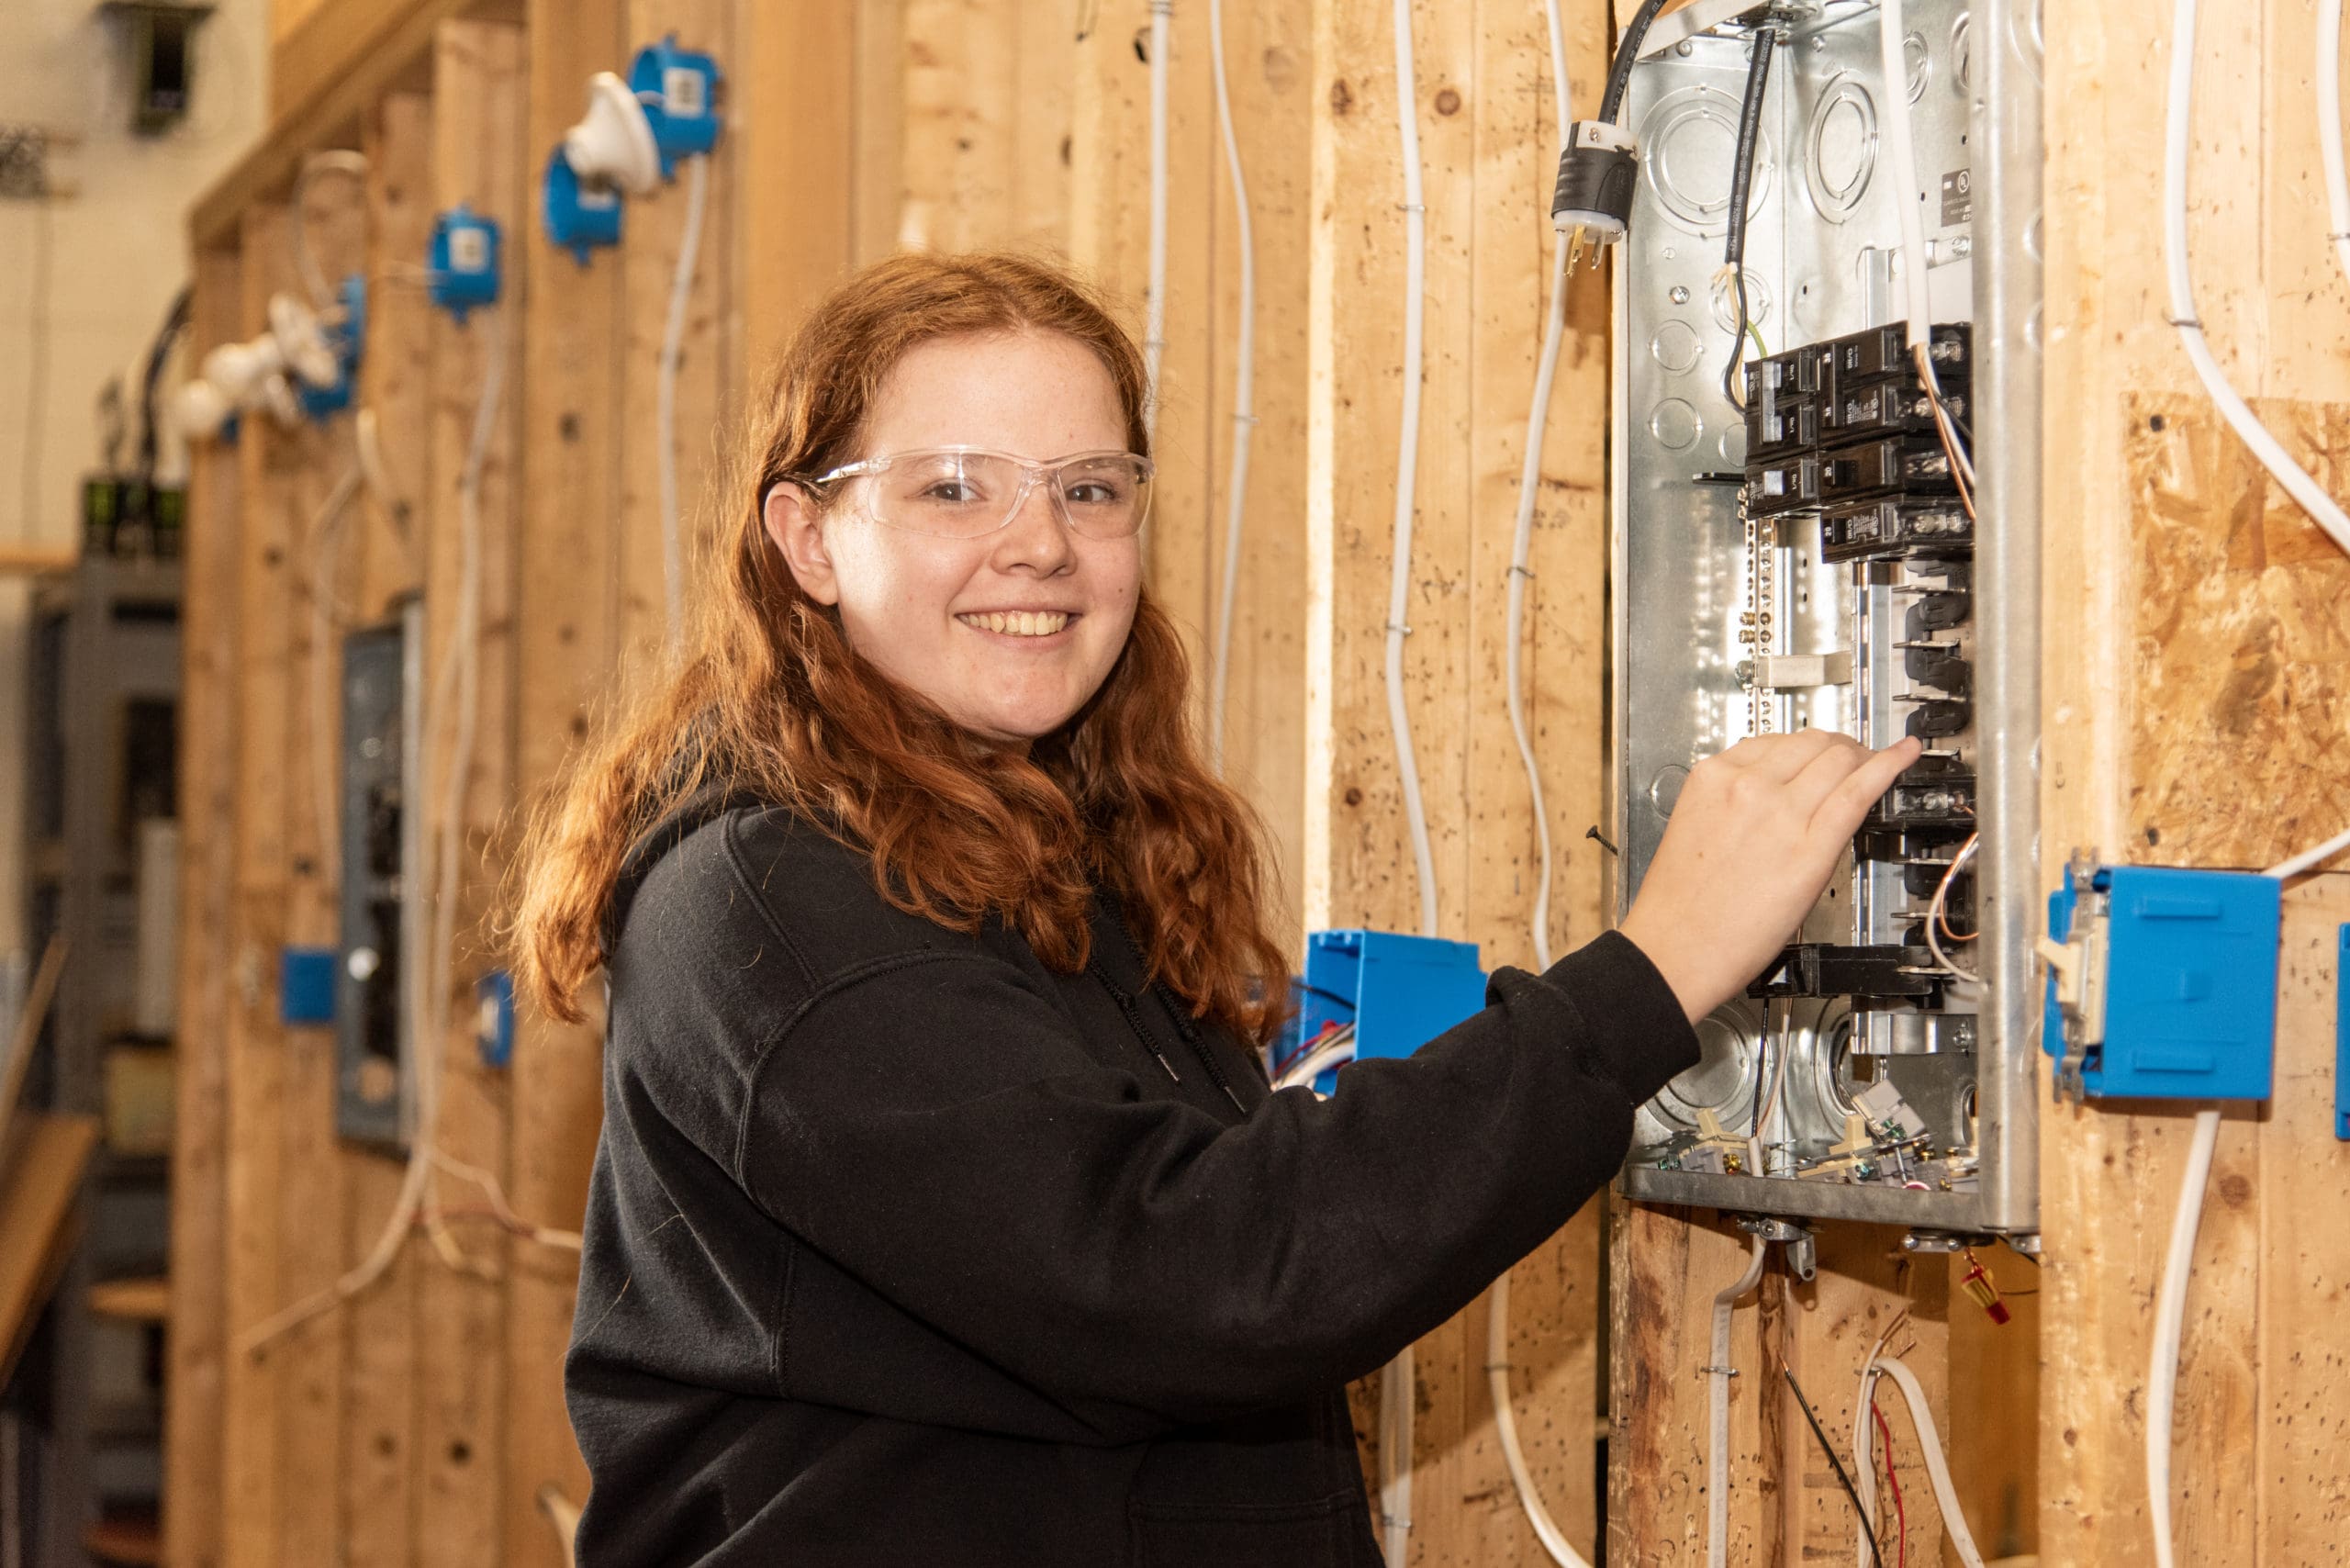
[1295,931,1485,1091]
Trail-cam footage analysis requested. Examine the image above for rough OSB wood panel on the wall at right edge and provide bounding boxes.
[2115,395,2350,869]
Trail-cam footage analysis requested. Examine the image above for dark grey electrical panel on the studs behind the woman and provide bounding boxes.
[334,599,423,1149]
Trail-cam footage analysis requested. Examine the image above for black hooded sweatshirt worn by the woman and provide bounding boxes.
[566,797,1696,1568]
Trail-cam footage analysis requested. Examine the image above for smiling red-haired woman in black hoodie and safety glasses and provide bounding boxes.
[517,256,1915,1568]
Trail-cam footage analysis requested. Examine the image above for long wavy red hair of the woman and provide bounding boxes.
[512,254,1288,1041]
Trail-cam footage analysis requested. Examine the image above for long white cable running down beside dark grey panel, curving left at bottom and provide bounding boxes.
[238,310,505,1357]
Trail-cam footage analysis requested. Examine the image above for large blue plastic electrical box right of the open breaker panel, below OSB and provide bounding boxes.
[2042,865,2282,1100]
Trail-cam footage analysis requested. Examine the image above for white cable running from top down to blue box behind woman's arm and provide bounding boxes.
[1380,0,1436,1568]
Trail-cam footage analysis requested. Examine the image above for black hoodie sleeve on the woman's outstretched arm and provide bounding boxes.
[733,934,1696,1441]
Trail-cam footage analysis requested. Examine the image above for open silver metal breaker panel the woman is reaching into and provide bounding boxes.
[1612,0,2030,1234]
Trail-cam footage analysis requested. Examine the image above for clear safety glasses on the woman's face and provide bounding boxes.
[815,447,1151,538]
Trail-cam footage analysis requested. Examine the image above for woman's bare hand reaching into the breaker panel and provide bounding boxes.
[1621,729,1925,1023]
